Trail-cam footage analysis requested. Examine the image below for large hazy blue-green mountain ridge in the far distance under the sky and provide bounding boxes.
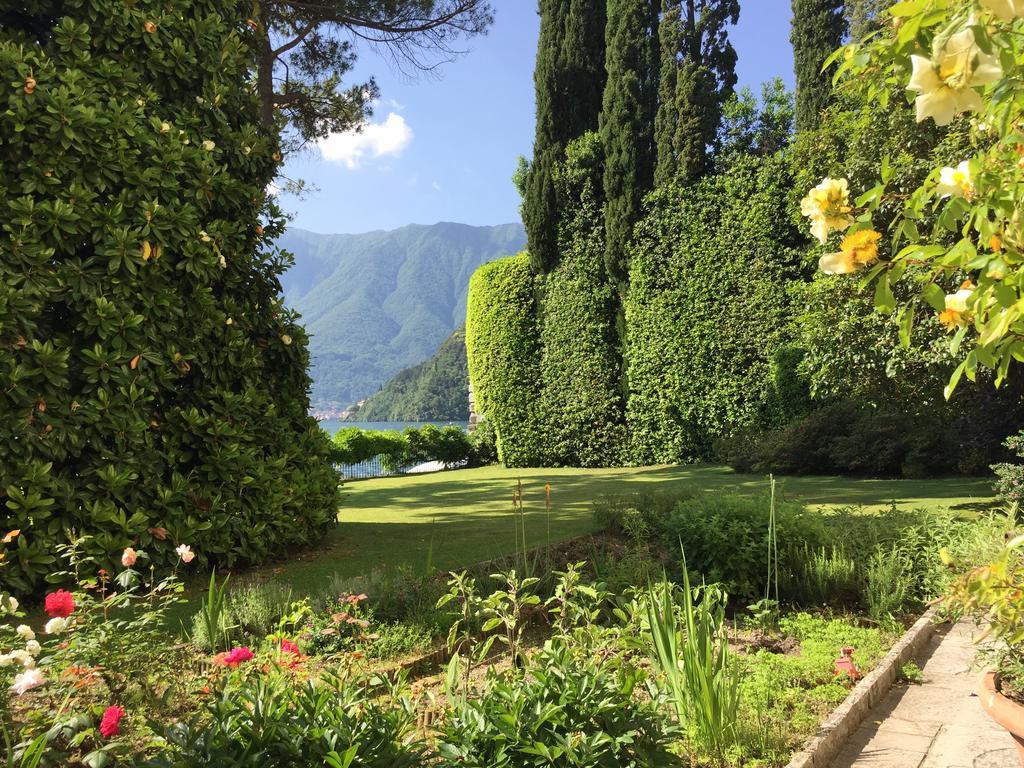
[279,222,526,409]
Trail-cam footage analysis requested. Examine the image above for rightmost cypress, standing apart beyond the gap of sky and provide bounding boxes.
[790,0,846,131]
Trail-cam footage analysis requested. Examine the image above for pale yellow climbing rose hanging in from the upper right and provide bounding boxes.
[802,0,1024,396]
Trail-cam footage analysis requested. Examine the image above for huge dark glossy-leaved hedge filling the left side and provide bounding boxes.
[0,0,337,592]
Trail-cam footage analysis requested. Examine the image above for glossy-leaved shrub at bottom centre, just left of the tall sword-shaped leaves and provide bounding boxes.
[437,639,681,768]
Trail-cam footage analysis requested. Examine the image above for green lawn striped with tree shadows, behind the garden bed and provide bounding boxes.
[234,465,992,592]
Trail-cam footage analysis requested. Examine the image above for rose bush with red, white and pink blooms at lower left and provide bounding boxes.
[0,532,190,765]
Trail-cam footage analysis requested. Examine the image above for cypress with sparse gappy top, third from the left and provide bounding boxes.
[656,0,739,183]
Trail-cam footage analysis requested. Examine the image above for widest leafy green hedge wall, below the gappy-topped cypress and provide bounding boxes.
[626,157,803,464]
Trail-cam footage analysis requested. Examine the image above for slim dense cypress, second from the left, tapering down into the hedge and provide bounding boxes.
[599,0,658,292]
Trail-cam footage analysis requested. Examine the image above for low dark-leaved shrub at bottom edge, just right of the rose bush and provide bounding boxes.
[153,674,424,768]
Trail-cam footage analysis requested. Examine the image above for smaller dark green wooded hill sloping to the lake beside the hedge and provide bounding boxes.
[351,328,469,421]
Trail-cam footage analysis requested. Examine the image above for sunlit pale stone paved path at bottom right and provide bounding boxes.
[831,623,1019,768]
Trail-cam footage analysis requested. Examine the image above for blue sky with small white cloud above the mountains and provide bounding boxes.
[282,0,793,232]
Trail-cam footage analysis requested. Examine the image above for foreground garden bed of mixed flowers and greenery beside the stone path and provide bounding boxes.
[0,489,1004,768]
